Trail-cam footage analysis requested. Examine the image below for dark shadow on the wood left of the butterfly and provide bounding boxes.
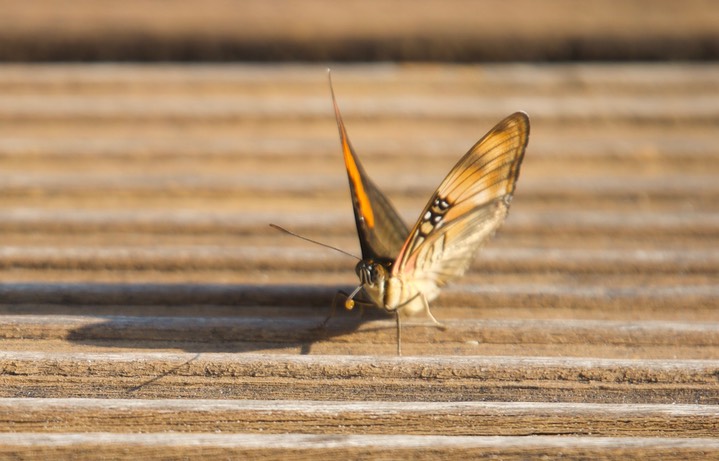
[0,284,394,353]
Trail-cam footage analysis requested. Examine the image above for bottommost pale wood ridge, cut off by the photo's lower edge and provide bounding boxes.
[0,433,719,460]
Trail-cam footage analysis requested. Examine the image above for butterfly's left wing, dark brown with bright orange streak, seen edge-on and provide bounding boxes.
[330,80,409,261]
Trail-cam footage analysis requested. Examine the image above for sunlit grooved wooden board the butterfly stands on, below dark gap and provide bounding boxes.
[0,64,719,459]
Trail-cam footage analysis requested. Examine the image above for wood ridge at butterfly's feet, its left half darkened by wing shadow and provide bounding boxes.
[0,312,719,353]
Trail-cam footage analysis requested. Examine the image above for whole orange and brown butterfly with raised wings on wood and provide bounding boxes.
[330,73,529,355]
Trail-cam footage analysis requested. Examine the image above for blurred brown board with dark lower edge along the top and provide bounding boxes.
[0,0,719,62]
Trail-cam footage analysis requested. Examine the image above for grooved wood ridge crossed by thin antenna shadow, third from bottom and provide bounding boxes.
[0,352,719,404]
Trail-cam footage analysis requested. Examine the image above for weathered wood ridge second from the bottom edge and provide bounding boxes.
[0,398,719,438]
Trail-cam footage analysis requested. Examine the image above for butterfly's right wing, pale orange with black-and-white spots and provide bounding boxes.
[392,112,529,294]
